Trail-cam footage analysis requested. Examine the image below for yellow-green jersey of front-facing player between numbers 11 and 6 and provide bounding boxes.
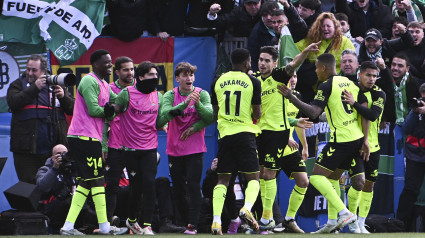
[255,68,291,131]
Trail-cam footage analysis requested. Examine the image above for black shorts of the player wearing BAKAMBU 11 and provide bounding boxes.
[217,132,260,174]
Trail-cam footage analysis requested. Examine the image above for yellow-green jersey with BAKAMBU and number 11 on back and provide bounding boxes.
[211,71,261,138]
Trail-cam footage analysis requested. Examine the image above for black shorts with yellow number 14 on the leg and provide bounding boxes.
[68,137,103,179]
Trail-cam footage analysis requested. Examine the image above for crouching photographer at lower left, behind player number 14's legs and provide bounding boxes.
[36,144,97,233]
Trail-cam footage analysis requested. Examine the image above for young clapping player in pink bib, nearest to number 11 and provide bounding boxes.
[162,62,214,235]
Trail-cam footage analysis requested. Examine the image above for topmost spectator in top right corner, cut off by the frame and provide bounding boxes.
[392,0,424,23]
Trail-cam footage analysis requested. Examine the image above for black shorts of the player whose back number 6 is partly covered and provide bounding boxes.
[316,138,364,172]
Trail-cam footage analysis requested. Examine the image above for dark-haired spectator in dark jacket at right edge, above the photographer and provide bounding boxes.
[402,22,425,79]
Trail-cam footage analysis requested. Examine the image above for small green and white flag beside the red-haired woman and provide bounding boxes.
[278,26,300,67]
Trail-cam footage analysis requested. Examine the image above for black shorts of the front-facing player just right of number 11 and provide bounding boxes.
[257,130,290,170]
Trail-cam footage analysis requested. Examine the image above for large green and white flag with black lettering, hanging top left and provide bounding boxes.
[0,0,105,65]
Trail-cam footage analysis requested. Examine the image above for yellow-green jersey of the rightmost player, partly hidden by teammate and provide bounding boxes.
[364,85,386,153]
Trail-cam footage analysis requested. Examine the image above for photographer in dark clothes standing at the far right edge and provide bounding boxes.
[397,83,425,231]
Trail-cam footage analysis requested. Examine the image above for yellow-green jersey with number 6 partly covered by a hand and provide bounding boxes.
[312,76,367,143]
